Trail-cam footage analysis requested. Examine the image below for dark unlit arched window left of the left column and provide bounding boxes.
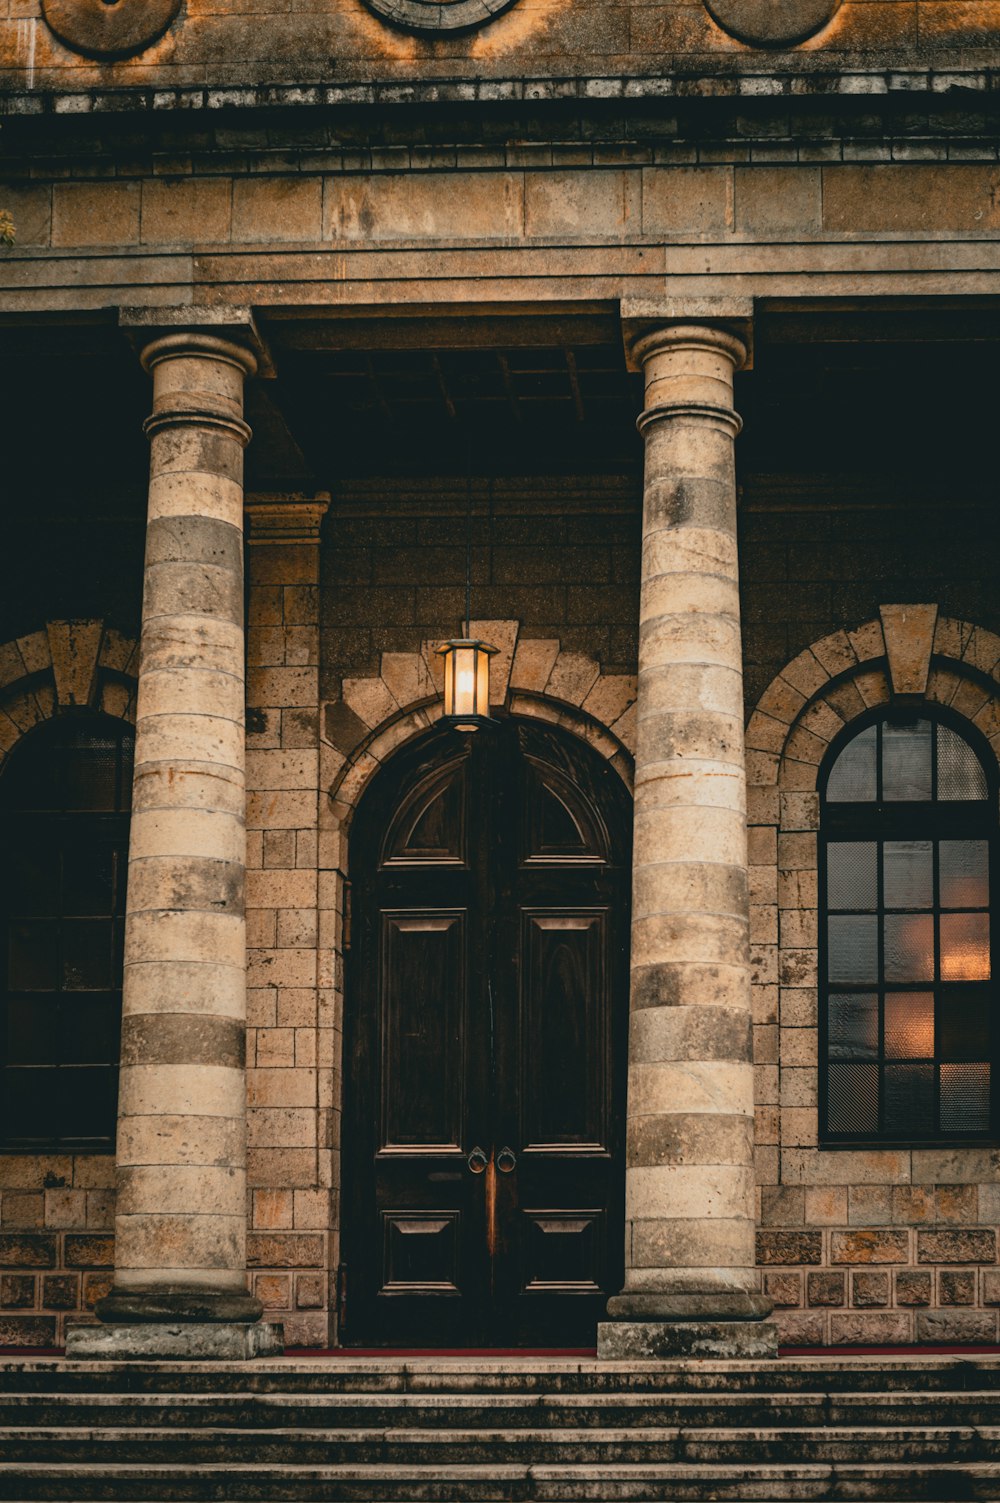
[0,715,134,1148]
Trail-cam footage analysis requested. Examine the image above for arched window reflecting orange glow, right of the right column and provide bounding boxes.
[820,706,1000,1145]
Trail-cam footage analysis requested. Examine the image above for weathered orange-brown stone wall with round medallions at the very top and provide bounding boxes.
[0,0,1000,92]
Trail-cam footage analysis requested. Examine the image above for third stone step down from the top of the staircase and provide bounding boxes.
[3,1426,1000,1467]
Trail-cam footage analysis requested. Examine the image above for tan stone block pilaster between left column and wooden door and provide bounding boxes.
[247,494,330,1347]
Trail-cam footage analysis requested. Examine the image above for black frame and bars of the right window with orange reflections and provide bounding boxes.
[817,700,1000,1150]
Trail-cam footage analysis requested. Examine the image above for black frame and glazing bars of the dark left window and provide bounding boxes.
[0,709,135,1154]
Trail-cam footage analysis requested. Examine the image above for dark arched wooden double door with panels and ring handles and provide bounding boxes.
[341,718,632,1347]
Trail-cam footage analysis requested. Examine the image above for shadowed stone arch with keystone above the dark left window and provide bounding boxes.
[0,619,138,768]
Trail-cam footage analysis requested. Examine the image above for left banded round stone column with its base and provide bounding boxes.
[69,317,278,1357]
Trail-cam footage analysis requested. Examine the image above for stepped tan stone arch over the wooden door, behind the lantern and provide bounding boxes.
[320,621,636,831]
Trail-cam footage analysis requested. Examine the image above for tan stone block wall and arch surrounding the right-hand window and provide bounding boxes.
[747,607,1000,1345]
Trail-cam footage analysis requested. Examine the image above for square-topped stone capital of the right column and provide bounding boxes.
[621,298,753,371]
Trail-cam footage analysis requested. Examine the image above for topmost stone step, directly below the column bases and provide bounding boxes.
[0,1356,1000,1395]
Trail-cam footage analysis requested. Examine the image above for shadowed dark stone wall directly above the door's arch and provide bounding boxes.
[322,476,639,700]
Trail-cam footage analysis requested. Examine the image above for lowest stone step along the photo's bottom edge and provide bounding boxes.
[0,1461,1000,1503]
